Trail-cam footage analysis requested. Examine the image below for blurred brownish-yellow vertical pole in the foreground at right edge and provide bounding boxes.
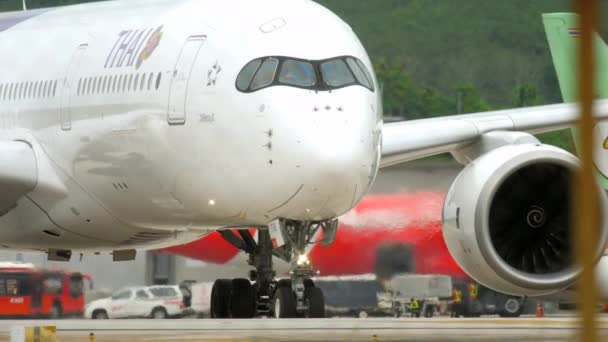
[575,0,599,342]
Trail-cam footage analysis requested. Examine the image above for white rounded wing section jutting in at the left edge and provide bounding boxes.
[0,141,38,216]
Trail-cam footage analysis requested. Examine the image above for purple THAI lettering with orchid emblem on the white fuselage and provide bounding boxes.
[104,25,163,69]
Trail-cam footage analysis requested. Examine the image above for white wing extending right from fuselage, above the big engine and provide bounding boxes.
[380,100,608,167]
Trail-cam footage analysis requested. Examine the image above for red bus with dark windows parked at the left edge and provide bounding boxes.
[0,263,90,318]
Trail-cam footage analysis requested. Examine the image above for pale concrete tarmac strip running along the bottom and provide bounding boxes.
[0,317,608,342]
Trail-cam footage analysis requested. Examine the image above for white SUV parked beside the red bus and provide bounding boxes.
[85,285,184,319]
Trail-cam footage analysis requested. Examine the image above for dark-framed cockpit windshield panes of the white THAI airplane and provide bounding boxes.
[236,56,374,92]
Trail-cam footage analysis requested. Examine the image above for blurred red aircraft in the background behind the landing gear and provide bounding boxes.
[162,192,468,279]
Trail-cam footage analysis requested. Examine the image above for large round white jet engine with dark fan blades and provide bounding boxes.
[443,143,608,295]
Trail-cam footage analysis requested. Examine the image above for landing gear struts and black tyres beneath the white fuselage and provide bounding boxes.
[211,220,338,318]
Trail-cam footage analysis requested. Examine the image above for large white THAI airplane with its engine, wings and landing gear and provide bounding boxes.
[0,0,608,317]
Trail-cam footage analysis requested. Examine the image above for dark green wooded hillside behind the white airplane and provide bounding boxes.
[319,0,608,107]
